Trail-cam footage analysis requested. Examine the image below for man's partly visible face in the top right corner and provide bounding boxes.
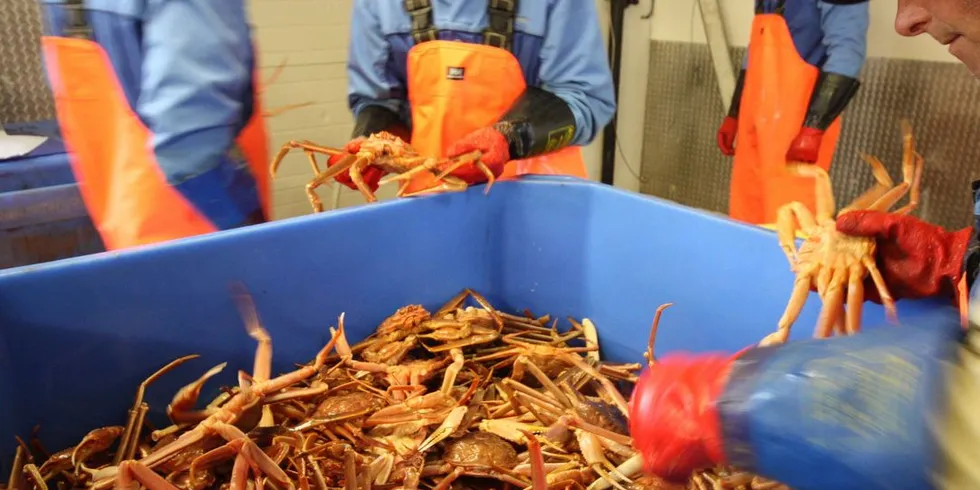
[895,0,980,78]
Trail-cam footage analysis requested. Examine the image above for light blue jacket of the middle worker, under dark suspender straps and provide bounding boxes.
[347,0,615,145]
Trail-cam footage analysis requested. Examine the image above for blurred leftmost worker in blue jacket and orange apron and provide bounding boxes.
[36,0,269,250]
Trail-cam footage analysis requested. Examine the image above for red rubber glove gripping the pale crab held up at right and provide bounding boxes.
[837,211,973,304]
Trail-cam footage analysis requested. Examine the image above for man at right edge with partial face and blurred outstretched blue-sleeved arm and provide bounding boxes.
[630,0,980,490]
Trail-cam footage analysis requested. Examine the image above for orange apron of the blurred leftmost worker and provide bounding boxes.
[41,36,269,250]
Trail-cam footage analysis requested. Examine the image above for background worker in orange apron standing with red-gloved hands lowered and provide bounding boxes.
[718,0,869,226]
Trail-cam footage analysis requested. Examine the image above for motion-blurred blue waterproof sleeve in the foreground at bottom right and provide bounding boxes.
[718,309,963,490]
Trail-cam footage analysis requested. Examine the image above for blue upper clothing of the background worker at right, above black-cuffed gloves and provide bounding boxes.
[755,0,868,77]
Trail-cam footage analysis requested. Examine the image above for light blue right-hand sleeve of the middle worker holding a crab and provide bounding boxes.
[539,0,616,145]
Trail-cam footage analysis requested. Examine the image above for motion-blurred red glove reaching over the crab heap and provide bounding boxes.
[629,354,735,481]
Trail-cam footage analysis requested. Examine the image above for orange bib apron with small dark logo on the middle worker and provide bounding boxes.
[398,2,588,193]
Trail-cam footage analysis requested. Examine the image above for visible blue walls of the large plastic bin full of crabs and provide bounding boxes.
[0,178,939,468]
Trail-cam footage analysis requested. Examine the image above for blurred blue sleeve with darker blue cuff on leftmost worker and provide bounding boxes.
[136,0,259,229]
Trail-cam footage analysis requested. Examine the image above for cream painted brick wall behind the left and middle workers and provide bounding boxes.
[249,0,607,219]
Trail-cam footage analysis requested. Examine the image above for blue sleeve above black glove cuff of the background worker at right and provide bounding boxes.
[817,1,870,78]
